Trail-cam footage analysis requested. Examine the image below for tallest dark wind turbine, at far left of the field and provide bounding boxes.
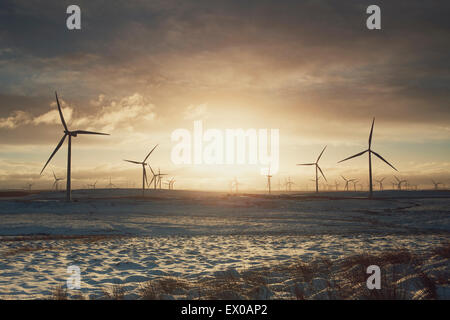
[41,91,109,201]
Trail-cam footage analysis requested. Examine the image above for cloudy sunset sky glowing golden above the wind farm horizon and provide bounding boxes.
[0,0,450,190]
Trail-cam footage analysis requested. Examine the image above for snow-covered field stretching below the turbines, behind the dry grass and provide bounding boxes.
[0,189,450,299]
